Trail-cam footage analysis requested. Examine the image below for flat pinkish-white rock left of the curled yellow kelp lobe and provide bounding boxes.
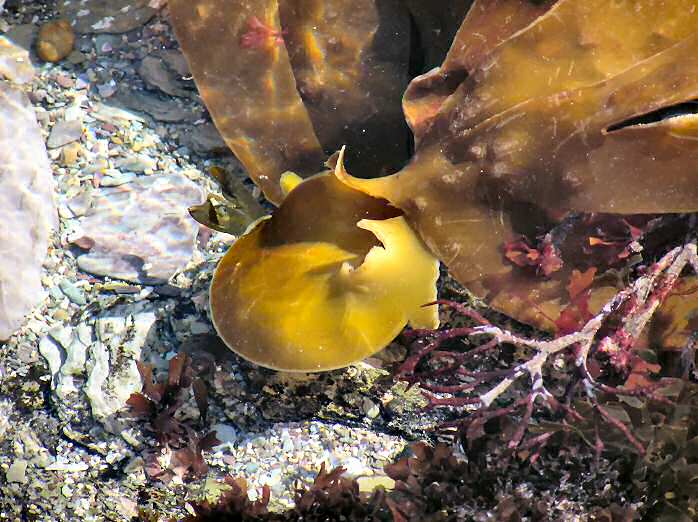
[78,174,203,284]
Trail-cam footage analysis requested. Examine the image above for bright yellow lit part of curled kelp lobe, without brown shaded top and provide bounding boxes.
[211,217,438,372]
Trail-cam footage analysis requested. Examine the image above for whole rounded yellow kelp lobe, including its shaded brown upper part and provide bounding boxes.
[211,173,438,372]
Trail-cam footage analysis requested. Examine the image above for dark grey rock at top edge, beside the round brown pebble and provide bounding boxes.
[58,0,157,34]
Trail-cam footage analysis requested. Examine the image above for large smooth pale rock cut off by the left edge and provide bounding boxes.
[0,41,57,339]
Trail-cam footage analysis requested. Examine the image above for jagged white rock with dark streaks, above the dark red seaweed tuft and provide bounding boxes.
[84,302,156,419]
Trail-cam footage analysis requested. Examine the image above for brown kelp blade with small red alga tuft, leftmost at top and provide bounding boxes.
[169,0,324,202]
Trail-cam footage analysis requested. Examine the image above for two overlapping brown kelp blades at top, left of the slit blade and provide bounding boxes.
[169,0,410,204]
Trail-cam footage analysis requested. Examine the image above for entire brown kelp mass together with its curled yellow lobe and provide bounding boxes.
[170,0,698,371]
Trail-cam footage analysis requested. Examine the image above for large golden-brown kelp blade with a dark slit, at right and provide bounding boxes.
[345,0,698,328]
